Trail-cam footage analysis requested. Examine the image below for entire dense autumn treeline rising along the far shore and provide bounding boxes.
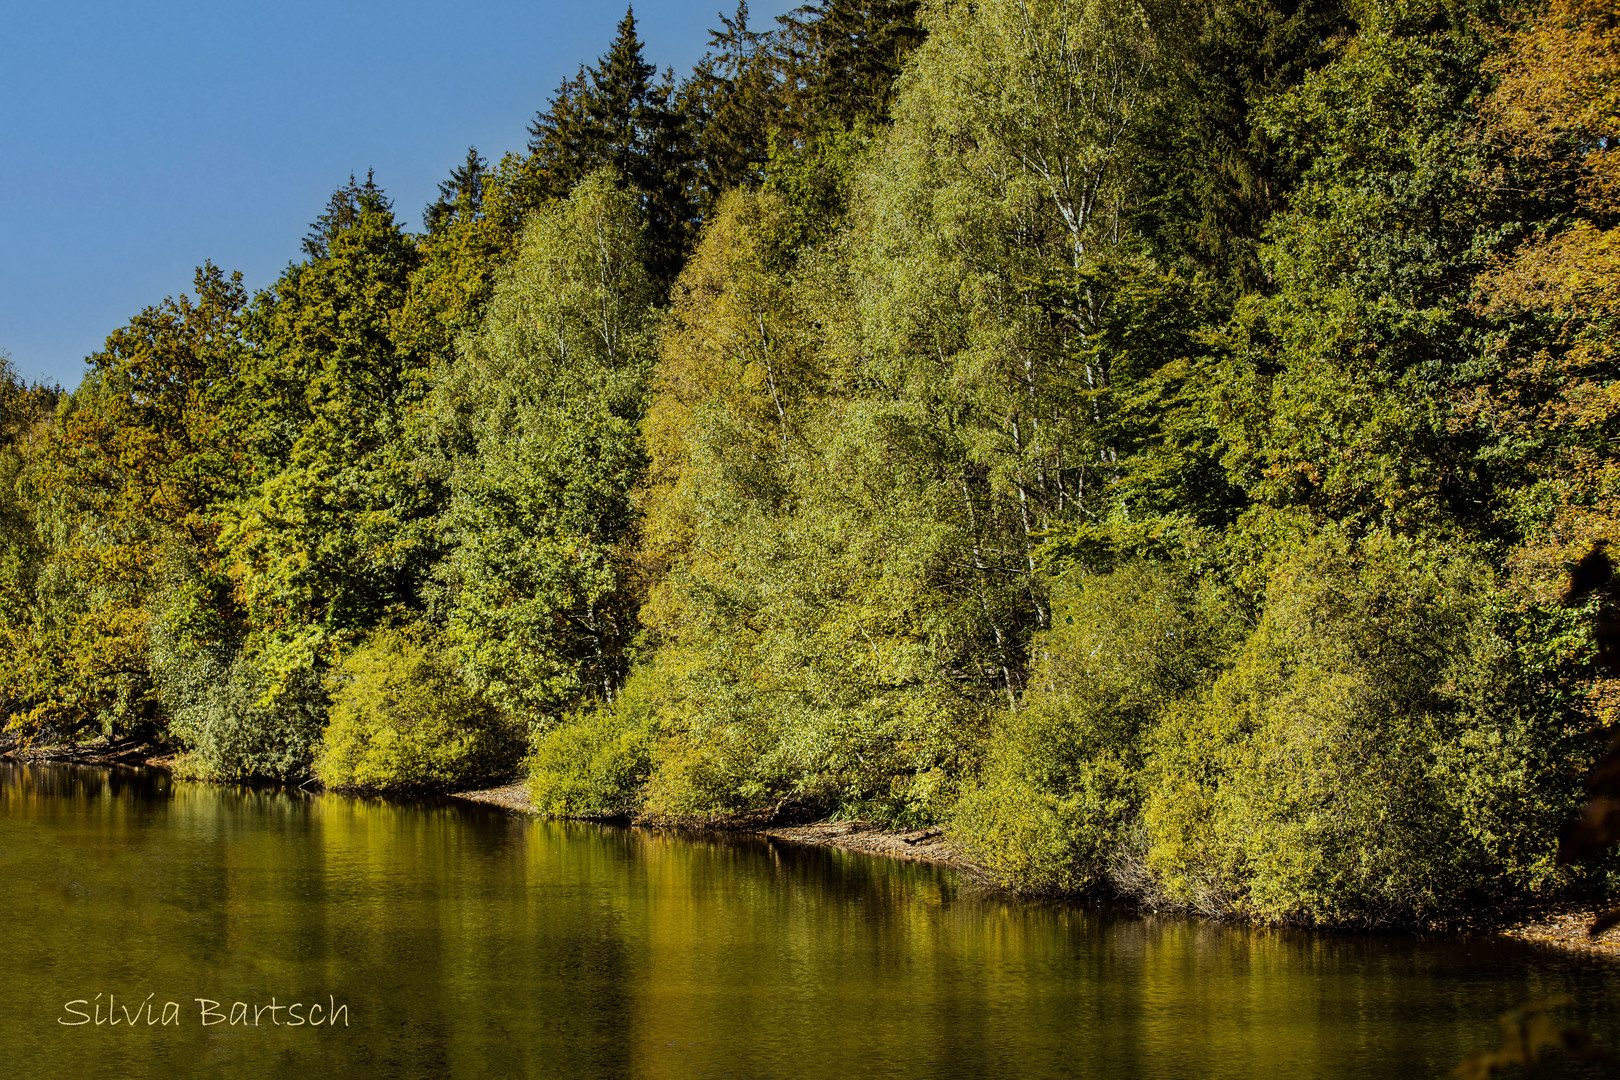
[0,0,1620,923]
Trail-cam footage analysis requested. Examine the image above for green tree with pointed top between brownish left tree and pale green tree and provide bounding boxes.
[220,176,436,689]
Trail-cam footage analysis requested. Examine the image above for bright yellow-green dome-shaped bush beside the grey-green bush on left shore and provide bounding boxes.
[314,630,523,792]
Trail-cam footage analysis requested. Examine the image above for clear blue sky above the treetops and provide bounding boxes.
[0,0,797,389]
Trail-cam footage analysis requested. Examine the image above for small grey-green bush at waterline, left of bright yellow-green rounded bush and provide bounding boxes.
[168,657,327,780]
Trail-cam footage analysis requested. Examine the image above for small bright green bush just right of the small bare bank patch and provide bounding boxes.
[528,678,658,818]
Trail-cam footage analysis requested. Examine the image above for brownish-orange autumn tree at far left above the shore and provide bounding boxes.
[6,264,246,735]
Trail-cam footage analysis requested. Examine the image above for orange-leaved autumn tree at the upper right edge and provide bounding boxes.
[1477,0,1620,595]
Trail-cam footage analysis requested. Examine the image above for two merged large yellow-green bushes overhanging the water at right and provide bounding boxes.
[956,529,1584,925]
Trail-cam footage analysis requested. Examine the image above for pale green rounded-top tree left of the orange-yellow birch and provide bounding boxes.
[439,172,651,719]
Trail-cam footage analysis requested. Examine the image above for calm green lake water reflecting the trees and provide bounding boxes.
[0,764,1620,1080]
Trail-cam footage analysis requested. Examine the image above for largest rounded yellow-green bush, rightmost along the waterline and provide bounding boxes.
[1144,536,1573,925]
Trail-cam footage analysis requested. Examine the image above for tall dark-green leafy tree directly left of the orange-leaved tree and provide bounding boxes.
[1217,5,1495,534]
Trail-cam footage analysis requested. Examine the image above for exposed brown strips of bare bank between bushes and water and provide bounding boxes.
[12,738,1620,960]
